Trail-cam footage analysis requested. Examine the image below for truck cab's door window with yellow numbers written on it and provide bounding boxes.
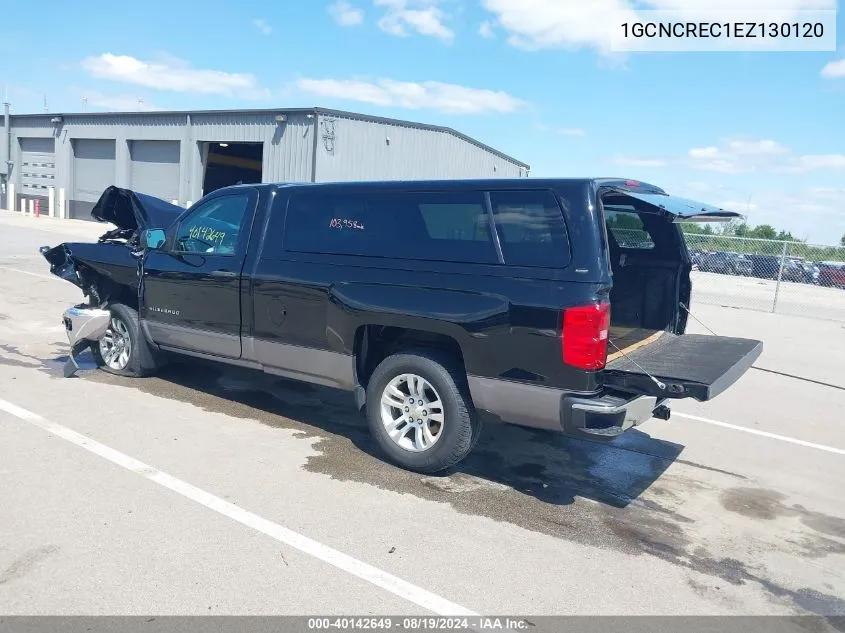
[173,193,249,255]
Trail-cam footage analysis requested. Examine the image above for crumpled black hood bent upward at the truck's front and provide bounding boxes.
[91,186,185,231]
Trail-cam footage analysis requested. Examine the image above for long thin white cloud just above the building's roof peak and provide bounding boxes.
[296,78,527,114]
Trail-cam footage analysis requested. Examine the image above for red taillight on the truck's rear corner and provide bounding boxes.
[562,302,610,370]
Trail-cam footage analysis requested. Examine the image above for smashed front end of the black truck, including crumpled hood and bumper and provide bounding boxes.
[39,187,184,377]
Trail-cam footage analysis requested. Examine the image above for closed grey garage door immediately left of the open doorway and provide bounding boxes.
[129,141,179,202]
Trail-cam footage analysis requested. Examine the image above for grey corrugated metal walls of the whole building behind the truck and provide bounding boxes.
[6,110,527,217]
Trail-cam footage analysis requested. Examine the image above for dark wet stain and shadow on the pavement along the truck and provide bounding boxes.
[9,350,845,615]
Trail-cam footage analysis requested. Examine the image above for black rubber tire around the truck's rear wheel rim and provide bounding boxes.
[366,349,481,474]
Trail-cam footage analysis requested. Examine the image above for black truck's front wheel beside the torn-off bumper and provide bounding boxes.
[91,303,154,377]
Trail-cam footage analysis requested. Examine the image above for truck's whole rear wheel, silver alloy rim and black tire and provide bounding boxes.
[367,350,481,473]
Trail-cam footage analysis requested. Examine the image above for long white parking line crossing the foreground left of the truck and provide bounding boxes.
[0,399,478,616]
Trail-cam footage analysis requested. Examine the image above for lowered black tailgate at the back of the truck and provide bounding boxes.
[604,333,763,401]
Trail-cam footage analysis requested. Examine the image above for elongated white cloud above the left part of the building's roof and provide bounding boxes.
[81,53,267,98]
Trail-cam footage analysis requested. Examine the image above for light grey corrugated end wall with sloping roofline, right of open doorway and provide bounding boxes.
[316,114,526,182]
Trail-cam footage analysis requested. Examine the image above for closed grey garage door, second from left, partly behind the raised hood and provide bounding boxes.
[68,138,115,220]
